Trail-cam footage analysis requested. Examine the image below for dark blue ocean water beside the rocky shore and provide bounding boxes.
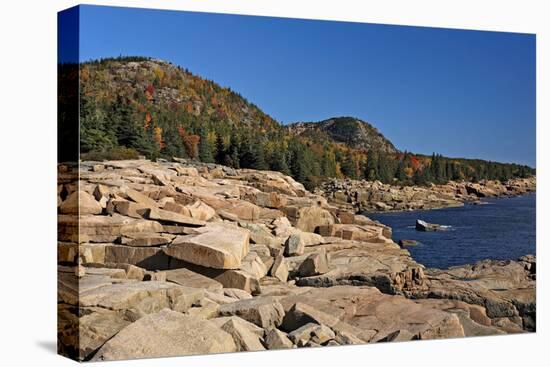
[365,194,536,268]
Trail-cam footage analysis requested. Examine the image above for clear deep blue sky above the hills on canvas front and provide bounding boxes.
[71,6,536,167]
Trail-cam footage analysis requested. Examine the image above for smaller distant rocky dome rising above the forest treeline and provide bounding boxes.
[288,117,398,154]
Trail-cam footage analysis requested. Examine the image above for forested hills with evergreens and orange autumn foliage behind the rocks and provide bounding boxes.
[63,57,534,188]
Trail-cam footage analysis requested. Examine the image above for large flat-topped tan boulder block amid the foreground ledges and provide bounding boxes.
[164,225,250,269]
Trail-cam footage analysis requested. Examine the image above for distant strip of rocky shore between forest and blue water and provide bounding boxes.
[315,177,536,213]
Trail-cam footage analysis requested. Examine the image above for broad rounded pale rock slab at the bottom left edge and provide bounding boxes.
[92,309,237,361]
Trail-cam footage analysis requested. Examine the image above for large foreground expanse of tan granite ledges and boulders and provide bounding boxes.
[58,160,536,360]
